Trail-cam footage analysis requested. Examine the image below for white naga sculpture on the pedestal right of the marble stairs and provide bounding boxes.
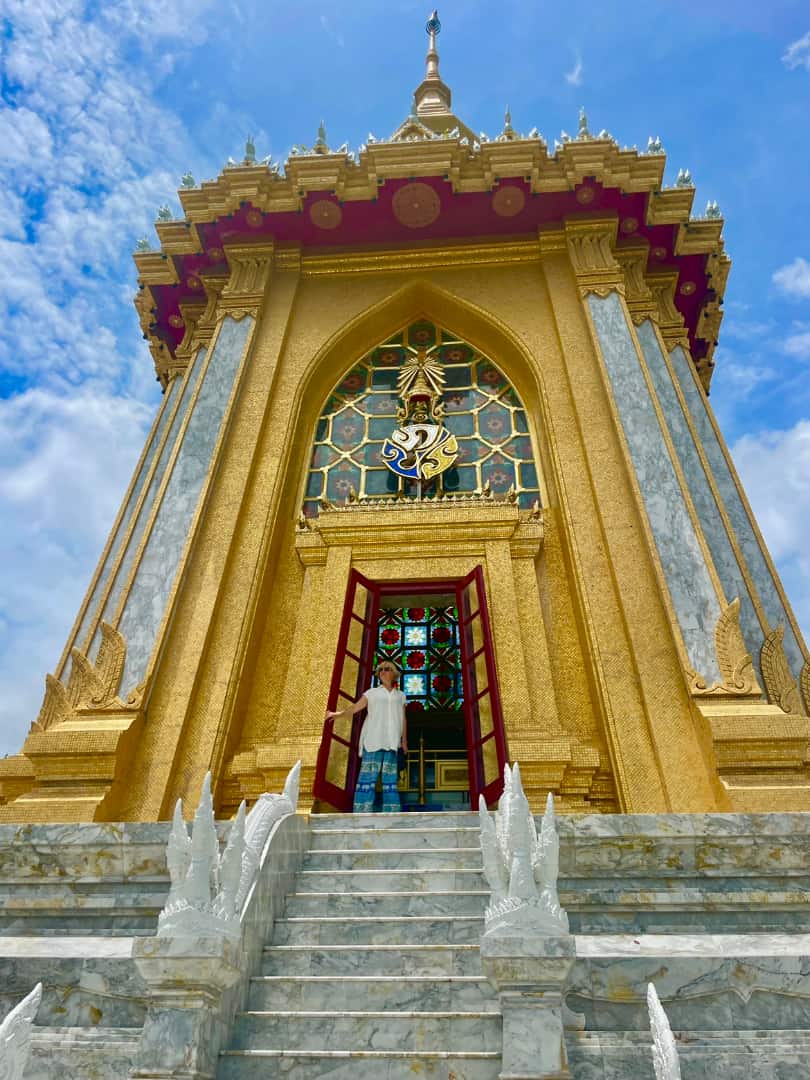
[478,762,569,936]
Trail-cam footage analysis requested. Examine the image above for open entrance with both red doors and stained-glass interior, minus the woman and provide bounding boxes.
[314,566,507,812]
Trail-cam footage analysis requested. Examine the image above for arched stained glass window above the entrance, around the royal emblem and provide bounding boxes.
[303,321,540,516]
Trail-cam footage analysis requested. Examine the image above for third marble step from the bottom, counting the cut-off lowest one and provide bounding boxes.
[248,975,500,1013]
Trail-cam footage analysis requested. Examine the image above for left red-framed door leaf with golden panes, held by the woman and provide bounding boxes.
[312,570,380,813]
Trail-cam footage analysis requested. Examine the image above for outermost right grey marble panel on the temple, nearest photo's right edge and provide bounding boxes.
[670,346,805,678]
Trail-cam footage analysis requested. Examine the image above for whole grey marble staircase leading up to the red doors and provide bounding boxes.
[218,812,501,1080]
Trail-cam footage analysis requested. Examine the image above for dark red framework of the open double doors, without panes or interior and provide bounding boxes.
[313,565,507,812]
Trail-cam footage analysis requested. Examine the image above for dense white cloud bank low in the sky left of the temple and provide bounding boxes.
[0,384,154,754]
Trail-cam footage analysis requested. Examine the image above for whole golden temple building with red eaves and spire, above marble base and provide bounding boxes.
[0,12,810,823]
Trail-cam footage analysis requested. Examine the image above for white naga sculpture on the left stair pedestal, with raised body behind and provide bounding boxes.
[158,761,301,937]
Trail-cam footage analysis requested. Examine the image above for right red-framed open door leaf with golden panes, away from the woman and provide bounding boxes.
[456,566,507,810]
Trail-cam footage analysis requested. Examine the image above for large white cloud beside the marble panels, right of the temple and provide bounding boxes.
[731,419,810,652]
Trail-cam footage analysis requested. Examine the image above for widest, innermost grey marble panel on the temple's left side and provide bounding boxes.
[118,318,253,696]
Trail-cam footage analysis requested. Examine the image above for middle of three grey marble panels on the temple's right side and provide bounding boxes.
[637,320,764,676]
